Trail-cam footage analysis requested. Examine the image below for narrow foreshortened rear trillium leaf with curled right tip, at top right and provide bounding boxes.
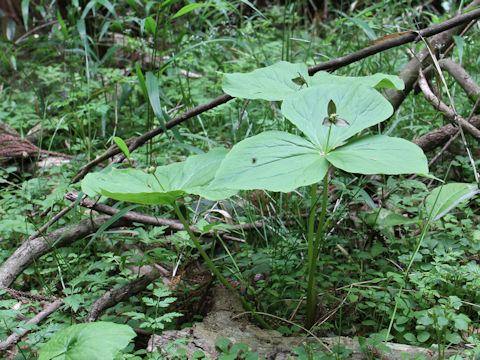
[309,71,405,90]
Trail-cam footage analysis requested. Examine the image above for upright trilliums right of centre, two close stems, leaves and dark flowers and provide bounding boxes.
[210,62,428,327]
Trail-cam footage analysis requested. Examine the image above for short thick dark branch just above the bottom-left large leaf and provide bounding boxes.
[87,268,160,322]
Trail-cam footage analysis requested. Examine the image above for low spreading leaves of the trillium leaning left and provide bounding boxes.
[82,148,235,205]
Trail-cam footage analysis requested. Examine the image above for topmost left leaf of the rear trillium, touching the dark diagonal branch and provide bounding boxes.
[222,61,309,101]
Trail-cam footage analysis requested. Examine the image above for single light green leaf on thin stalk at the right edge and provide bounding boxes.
[425,183,480,221]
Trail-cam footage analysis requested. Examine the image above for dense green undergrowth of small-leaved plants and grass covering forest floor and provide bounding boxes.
[0,1,480,359]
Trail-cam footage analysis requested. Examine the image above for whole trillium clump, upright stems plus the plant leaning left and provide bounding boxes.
[82,62,476,327]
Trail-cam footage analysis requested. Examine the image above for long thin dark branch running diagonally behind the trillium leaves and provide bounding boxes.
[72,6,480,183]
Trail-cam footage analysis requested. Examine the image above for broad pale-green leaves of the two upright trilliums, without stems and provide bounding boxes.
[211,62,428,192]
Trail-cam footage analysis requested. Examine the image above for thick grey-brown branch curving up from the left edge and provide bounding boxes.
[0,215,128,287]
